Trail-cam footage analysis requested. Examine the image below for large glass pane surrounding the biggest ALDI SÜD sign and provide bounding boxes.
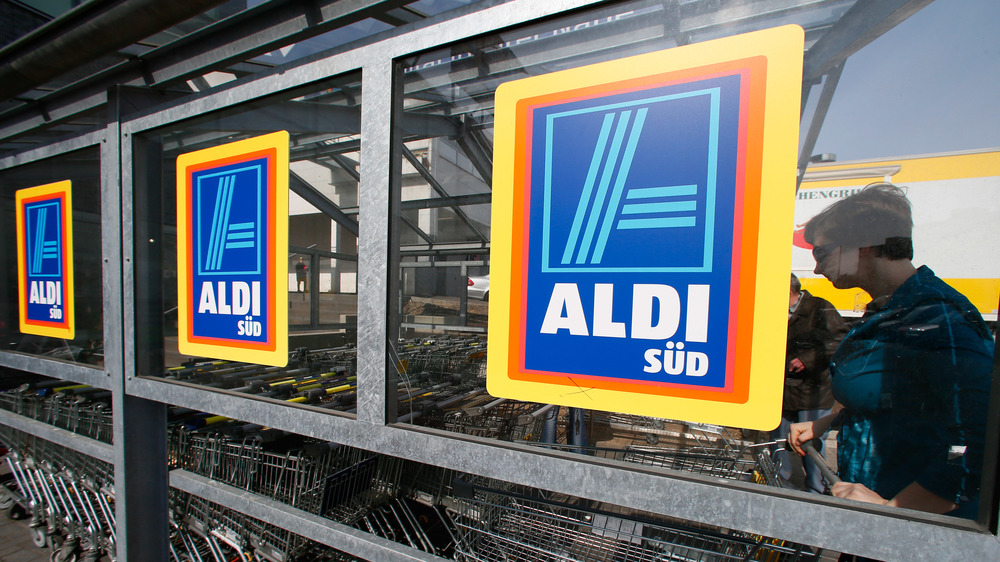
[396,0,1000,519]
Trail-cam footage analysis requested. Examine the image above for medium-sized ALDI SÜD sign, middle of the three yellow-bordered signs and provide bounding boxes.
[177,131,288,366]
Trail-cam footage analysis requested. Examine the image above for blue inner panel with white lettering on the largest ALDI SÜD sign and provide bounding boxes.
[524,74,740,389]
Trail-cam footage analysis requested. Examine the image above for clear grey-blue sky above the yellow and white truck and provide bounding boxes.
[802,0,1000,162]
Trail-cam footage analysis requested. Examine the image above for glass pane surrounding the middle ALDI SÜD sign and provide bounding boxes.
[135,73,361,416]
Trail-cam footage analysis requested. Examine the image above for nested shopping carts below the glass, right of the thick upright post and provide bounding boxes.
[160,406,820,561]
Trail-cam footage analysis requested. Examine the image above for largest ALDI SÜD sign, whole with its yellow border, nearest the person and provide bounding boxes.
[488,26,803,429]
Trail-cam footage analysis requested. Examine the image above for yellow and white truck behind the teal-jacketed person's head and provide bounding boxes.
[792,148,1000,322]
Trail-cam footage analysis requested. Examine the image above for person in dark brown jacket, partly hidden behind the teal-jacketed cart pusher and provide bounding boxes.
[772,274,847,494]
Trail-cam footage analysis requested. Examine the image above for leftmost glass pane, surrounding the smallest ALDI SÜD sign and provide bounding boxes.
[0,148,104,367]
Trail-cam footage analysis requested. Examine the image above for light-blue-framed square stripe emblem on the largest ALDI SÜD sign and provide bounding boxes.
[541,88,719,272]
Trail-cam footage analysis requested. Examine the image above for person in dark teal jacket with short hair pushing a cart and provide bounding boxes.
[788,183,995,519]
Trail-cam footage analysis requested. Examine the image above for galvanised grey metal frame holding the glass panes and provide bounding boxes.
[0,0,1000,560]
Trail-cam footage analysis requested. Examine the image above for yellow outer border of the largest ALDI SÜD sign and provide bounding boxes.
[487,25,804,430]
